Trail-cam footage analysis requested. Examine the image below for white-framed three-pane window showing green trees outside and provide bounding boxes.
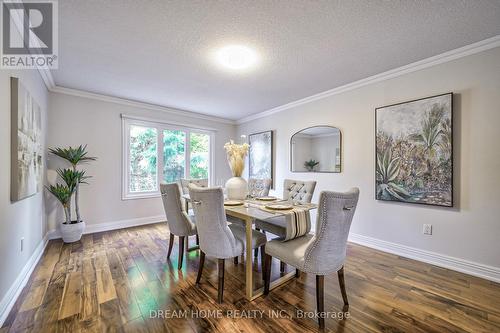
[122,116,213,199]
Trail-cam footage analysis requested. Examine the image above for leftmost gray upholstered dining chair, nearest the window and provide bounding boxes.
[160,183,196,269]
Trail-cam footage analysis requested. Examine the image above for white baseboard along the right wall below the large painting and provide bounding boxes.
[349,233,500,282]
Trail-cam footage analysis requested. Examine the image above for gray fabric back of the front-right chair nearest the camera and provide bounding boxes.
[304,188,359,275]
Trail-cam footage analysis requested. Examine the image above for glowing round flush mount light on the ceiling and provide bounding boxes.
[215,45,258,71]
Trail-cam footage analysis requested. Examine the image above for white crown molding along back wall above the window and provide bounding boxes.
[49,86,236,125]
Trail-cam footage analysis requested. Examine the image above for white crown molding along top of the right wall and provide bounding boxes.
[236,35,500,125]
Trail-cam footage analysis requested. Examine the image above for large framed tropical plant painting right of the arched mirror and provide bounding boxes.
[375,93,453,207]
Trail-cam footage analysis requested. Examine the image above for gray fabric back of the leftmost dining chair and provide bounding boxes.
[160,183,193,236]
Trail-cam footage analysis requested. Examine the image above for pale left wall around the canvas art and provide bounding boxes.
[0,69,48,308]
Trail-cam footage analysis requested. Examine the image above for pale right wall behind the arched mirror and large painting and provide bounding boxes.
[238,48,500,268]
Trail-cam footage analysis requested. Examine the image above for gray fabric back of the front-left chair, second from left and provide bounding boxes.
[189,185,241,259]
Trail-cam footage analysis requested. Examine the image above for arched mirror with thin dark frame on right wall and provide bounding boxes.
[290,126,342,172]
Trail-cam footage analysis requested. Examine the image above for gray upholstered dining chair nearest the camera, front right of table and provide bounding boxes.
[264,188,359,328]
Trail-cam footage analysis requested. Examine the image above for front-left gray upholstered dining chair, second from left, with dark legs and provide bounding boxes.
[189,185,266,303]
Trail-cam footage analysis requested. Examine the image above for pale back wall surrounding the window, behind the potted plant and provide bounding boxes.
[48,93,235,230]
